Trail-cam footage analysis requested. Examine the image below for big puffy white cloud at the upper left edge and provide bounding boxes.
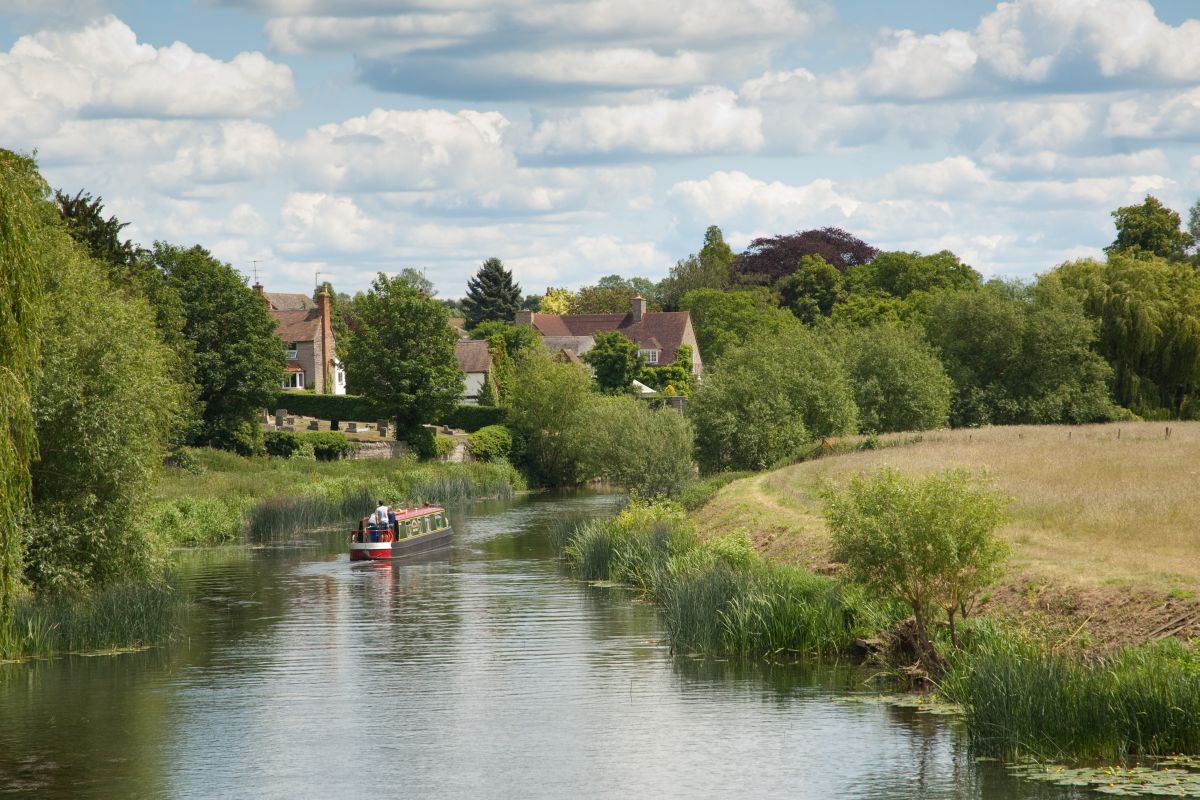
[0,17,296,133]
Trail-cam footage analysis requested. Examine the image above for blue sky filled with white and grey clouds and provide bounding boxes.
[0,0,1200,297]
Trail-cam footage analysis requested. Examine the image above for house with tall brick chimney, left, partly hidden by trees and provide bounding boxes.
[253,283,346,395]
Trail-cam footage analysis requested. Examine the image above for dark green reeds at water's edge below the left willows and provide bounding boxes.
[0,579,182,658]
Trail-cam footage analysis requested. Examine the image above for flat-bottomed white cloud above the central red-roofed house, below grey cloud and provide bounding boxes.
[522,86,762,156]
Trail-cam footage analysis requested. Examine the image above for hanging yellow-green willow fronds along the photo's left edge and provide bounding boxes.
[0,150,53,627]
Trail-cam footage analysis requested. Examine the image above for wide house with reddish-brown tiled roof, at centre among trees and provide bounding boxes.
[515,297,704,377]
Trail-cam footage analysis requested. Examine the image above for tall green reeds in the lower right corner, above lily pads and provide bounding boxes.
[941,624,1200,759]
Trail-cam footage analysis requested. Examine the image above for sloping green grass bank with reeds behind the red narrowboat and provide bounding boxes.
[146,450,523,546]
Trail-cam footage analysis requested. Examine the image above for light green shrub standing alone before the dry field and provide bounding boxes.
[826,469,1007,667]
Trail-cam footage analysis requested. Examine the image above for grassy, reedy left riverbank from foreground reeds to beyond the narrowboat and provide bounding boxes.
[0,449,524,660]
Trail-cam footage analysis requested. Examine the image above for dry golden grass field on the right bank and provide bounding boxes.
[696,422,1200,639]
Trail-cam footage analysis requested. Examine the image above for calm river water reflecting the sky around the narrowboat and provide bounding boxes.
[0,495,1070,800]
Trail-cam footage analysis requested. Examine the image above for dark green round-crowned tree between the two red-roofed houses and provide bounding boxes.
[338,272,463,439]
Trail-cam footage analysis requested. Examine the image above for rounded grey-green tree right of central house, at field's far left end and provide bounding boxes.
[688,328,858,473]
